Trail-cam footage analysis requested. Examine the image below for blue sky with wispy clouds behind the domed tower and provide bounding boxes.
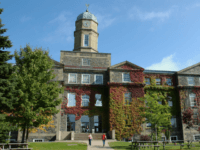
[0,0,200,71]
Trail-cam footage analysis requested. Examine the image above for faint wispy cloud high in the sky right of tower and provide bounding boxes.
[129,7,172,21]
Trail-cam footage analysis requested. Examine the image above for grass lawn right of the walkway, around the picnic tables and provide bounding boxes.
[108,142,200,150]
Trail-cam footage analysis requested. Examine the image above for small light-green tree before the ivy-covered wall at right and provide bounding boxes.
[140,91,172,140]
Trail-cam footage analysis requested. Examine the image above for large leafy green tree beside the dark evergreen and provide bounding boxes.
[10,45,64,142]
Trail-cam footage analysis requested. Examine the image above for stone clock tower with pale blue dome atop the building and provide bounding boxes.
[73,9,99,53]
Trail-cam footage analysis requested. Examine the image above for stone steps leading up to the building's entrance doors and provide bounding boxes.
[74,133,103,140]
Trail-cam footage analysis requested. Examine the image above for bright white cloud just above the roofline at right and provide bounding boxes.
[145,54,180,71]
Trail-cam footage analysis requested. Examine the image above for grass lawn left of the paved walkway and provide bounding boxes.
[28,142,87,150]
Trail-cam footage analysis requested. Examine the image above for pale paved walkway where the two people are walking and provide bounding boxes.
[63,139,117,150]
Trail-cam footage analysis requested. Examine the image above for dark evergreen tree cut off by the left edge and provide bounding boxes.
[0,9,19,143]
